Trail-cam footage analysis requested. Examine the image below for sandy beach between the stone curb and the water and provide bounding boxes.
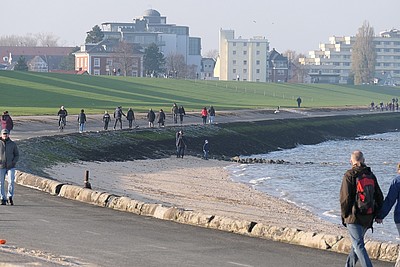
[45,156,346,235]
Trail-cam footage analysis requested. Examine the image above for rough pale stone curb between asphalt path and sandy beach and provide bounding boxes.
[16,171,400,262]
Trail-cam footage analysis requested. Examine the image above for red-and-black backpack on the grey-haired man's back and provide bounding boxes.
[355,173,376,215]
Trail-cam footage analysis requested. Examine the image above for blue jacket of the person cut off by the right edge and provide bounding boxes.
[377,175,400,223]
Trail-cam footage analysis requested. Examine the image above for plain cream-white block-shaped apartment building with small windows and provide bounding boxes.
[214,29,269,82]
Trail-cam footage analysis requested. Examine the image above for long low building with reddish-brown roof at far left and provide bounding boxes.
[0,46,76,72]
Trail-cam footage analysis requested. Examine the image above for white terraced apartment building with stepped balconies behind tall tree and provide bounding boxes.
[299,29,400,85]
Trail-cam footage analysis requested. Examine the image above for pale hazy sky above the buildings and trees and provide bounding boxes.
[0,0,400,54]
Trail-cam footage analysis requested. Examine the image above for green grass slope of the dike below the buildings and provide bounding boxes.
[0,71,400,115]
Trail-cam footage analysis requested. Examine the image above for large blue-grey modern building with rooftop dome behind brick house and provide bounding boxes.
[101,9,201,76]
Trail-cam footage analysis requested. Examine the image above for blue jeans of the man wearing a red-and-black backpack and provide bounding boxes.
[346,224,372,267]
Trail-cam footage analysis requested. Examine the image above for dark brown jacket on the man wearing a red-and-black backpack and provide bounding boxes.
[340,164,383,228]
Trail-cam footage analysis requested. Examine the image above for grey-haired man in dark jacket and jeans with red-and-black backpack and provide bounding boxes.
[340,150,383,267]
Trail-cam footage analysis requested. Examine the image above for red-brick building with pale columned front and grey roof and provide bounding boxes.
[74,39,143,77]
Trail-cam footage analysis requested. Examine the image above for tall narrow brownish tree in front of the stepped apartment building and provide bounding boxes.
[351,21,376,84]
